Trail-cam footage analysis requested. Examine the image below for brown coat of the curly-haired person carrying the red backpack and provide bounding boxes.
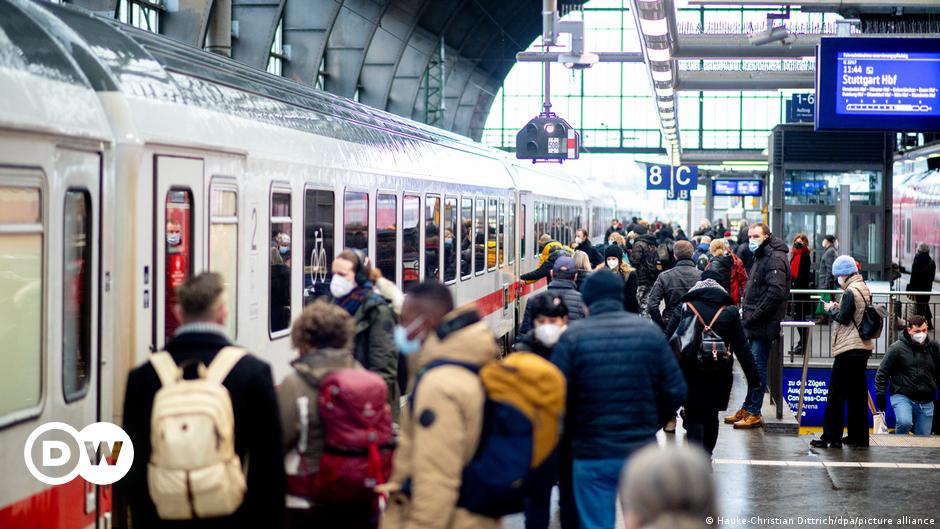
[277,349,361,508]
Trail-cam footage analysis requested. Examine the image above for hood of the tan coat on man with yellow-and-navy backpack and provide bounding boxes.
[418,306,499,368]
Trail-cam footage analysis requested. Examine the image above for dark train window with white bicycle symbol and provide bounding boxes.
[303,189,336,305]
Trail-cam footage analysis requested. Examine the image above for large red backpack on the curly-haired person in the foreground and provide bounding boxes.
[287,369,394,504]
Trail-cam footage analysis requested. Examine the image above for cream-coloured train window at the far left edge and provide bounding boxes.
[0,187,43,416]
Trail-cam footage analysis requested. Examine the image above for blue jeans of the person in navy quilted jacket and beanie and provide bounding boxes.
[574,458,624,529]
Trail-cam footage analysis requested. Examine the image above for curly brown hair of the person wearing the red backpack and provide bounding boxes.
[290,299,354,350]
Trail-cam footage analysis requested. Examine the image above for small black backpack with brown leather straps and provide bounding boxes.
[669,302,731,370]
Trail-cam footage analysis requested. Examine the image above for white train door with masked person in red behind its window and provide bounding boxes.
[153,156,206,350]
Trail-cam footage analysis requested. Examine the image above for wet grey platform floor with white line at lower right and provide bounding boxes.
[504,364,940,529]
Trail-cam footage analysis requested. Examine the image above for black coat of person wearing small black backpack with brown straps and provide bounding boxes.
[666,287,760,411]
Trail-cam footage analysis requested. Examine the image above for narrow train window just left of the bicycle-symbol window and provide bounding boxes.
[268,191,293,335]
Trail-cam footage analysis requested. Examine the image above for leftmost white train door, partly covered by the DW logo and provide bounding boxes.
[55,149,104,521]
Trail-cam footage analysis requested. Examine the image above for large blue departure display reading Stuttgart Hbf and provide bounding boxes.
[816,38,940,132]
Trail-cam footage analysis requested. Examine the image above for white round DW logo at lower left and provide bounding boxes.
[23,422,134,485]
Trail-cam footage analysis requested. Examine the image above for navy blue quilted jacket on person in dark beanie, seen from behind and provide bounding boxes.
[552,299,686,459]
